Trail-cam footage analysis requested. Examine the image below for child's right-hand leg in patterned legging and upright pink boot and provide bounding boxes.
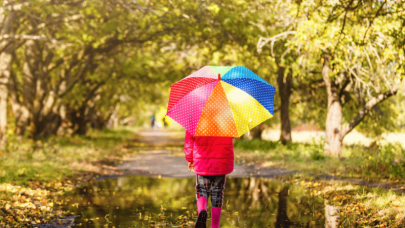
[211,175,225,228]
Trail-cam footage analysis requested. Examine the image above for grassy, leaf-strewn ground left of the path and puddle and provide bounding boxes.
[0,129,141,228]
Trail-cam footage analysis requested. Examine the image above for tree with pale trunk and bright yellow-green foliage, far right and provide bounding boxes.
[291,1,403,156]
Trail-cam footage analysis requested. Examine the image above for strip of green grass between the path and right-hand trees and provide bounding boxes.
[234,140,405,180]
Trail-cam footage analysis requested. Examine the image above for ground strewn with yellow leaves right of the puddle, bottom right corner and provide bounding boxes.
[292,180,405,227]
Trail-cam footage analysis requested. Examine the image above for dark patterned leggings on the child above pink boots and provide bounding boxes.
[195,175,225,207]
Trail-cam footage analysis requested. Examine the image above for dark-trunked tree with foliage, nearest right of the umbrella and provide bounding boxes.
[257,1,326,144]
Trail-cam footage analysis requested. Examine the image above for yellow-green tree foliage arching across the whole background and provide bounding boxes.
[3,0,404,139]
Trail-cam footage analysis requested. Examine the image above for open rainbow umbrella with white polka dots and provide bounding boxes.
[167,66,275,137]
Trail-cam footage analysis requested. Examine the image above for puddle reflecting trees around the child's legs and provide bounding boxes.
[58,176,325,228]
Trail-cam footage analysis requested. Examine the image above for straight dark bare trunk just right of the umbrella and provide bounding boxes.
[277,64,292,145]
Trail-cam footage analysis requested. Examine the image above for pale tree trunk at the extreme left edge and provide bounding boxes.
[0,0,15,148]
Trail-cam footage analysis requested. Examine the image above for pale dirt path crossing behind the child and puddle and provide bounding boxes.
[117,130,405,193]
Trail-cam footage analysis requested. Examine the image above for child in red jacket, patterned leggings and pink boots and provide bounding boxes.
[184,132,234,228]
